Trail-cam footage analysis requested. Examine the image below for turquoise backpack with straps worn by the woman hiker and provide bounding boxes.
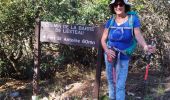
[109,11,137,56]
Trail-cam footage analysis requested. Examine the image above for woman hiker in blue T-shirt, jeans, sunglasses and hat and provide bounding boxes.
[101,0,155,100]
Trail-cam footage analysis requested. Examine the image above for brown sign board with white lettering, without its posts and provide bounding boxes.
[40,22,101,48]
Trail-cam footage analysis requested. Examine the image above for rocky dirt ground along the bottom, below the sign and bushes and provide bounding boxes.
[0,71,170,100]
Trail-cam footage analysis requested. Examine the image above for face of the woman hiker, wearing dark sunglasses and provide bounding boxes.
[114,2,125,15]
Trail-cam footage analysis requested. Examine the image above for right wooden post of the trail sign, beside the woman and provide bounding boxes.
[93,25,103,100]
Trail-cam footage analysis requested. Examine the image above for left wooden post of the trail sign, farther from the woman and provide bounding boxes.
[32,12,40,100]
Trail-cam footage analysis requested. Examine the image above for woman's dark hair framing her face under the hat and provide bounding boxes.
[109,0,131,14]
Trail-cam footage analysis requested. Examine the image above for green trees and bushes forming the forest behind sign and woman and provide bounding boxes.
[0,0,170,99]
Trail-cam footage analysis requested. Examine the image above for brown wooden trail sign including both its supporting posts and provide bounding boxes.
[33,20,104,99]
